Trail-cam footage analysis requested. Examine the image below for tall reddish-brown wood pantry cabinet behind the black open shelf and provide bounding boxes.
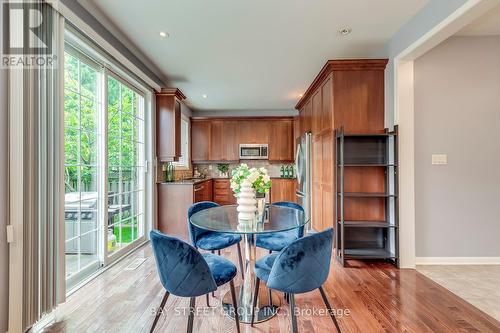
[296,59,387,235]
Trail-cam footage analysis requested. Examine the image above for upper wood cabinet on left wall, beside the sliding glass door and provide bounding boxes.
[156,89,186,161]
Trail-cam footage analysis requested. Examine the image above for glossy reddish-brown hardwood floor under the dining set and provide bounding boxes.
[45,244,500,333]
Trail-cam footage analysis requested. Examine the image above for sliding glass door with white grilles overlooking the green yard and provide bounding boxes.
[64,43,147,290]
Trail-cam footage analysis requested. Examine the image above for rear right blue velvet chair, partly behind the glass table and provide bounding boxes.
[255,201,304,253]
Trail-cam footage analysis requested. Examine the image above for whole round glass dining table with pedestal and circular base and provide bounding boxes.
[190,205,309,323]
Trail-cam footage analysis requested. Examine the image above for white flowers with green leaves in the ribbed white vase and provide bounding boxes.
[231,163,271,194]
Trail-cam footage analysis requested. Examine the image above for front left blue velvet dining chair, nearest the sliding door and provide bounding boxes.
[149,230,240,333]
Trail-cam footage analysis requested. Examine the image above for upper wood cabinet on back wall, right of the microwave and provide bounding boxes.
[269,119,294,162]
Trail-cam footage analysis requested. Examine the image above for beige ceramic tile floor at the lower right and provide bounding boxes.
[417,265,500,321]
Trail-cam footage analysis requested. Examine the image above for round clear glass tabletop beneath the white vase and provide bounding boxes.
[190,205,309,234]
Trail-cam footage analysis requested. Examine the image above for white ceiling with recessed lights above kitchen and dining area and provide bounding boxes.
[80,0,428,110]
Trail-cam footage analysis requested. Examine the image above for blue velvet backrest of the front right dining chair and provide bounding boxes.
[267,228,333,294]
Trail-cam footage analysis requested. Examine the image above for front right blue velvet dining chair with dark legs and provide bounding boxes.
[251,228,340,333]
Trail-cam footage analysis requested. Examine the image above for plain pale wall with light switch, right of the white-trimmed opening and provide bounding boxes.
[414,36,500,257]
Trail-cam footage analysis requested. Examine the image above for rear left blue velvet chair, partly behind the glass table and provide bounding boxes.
[188,201,244,277]
